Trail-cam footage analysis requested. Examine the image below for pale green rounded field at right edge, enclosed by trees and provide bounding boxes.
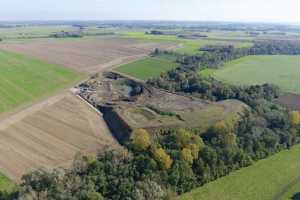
[200,55,300,93]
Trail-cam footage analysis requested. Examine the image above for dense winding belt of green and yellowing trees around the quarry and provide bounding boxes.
[0,39,300,200]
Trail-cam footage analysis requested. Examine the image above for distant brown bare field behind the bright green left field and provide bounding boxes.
[0,37,175,74]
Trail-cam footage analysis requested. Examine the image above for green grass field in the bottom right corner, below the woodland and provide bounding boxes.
[181,145,300,200]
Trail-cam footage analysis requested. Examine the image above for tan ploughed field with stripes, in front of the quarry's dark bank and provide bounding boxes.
[0,93,118,181]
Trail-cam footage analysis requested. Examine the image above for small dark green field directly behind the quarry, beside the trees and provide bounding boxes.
[115,56,177,80]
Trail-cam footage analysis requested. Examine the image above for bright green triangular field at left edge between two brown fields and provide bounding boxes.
[0,51,82,113]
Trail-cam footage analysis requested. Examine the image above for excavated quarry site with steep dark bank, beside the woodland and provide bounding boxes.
[79,73,249,143]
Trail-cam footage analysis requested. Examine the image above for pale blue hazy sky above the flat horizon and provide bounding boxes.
[0,0,300,23]
